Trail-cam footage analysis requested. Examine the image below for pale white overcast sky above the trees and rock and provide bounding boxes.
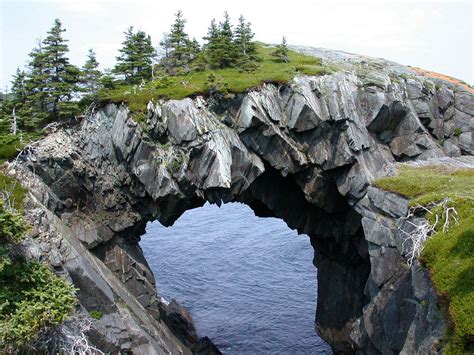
[0,0,474,89]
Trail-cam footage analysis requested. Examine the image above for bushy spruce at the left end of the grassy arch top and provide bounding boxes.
[114,26,156,84]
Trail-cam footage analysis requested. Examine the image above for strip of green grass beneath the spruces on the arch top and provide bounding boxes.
[100,44,335,122]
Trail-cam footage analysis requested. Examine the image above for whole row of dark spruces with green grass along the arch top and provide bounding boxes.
[0,11,334,143]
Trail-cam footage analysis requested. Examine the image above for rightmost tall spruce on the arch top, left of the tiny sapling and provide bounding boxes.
[234,15,257,71]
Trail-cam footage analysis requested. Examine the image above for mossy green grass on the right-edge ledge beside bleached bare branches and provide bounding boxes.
[375,166,474,354]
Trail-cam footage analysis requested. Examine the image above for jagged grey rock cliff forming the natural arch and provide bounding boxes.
[12,48,474,354]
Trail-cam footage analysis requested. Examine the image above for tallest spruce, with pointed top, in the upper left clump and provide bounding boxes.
[43,19,80,121]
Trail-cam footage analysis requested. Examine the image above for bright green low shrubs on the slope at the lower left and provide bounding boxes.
[0,174,76,353]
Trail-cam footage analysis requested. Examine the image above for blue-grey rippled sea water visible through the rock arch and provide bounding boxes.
[140,203,331,354]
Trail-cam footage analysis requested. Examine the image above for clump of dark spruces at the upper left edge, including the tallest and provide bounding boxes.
[0,19,83,145]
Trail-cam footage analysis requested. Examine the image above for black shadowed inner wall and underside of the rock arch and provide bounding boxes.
[121,165,370,353]
